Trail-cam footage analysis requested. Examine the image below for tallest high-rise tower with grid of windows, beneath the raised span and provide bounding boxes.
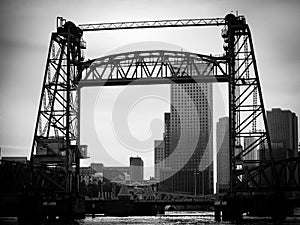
[166,81,213,194]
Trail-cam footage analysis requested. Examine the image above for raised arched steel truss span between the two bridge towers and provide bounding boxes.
[79,50,228,86]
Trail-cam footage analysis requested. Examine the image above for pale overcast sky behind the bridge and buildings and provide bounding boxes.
[0,0,300,179]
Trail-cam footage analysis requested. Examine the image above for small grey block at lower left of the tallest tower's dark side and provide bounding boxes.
[154,140,165,180]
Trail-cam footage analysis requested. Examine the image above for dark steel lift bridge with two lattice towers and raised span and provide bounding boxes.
[1,14,300,219]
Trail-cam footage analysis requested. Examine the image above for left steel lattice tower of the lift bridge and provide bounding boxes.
[31,18,85,193]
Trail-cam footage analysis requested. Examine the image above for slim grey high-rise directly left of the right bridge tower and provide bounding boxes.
[216,117,230,193]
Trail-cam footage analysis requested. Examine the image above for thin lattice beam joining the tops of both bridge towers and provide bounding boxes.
[79,18,225,31]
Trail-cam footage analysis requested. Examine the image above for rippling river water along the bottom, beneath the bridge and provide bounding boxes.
[0,211,300,225]
